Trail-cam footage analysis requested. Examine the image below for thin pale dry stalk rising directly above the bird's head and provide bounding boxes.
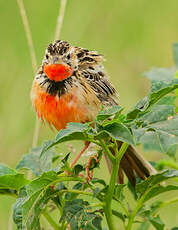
[54,0,67,40]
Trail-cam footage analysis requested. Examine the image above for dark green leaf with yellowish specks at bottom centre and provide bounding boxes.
[60,199,102,230]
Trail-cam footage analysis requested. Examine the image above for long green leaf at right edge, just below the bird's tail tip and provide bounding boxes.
[136,170,178,194]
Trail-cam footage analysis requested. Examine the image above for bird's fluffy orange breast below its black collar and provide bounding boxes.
[31,81,88,130]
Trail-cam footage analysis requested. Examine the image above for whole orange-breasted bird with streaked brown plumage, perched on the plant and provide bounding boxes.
[30,40,156,186]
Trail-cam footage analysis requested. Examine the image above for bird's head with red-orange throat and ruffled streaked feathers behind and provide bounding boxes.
[42,40,103,81]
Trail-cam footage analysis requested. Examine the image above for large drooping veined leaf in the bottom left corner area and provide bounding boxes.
[14,171,58,230]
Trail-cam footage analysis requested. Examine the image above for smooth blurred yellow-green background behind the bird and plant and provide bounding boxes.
[0,0,178,230]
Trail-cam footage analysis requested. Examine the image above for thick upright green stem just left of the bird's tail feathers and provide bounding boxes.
[103,142,128,230]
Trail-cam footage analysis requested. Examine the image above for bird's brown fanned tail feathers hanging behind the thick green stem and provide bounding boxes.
[105,141,157,187]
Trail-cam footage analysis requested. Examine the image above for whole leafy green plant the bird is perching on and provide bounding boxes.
[0,46,178,230]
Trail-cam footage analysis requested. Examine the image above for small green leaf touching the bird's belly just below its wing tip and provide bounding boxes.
[96,105,123,121]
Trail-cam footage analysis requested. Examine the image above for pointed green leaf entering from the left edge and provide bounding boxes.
[0,164,29,190]
